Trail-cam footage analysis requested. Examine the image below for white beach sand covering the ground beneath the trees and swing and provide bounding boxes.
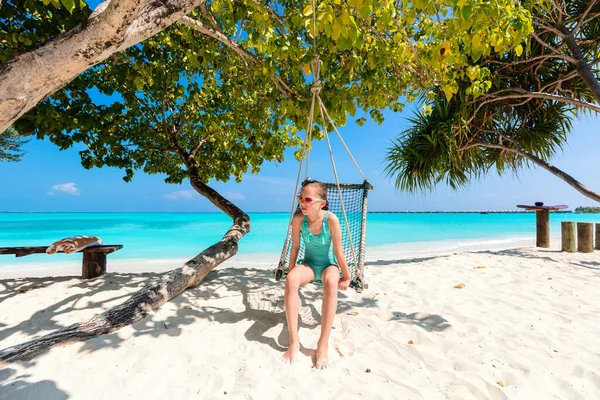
[0,245,600,400]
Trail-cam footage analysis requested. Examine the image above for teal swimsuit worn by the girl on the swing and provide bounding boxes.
[298,211,339,281]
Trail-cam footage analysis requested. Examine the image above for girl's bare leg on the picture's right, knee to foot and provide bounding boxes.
[316,265,340,369]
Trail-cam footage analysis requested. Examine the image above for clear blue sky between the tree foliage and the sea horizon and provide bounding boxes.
[0,107,600,212]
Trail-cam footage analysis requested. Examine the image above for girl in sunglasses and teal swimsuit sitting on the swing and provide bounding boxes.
[283,181,350,369]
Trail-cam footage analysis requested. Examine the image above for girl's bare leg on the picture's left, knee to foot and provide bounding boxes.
[283,264,315,363]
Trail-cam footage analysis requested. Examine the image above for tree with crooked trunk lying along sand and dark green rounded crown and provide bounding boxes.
[0,21,299,362]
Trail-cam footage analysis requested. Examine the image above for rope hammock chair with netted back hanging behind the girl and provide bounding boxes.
[275,8,373,292]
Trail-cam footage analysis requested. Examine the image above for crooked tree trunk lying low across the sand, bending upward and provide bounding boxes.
[0,169,250,366]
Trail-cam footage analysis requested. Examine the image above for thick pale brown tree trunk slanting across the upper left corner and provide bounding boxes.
[0,0,205,134]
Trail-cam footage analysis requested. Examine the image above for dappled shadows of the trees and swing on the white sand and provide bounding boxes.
[0,260,450,399]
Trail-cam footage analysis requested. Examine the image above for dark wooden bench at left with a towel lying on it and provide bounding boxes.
[0,244,123,279]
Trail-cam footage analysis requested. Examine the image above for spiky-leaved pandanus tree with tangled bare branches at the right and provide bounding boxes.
[386,0,600,201]
